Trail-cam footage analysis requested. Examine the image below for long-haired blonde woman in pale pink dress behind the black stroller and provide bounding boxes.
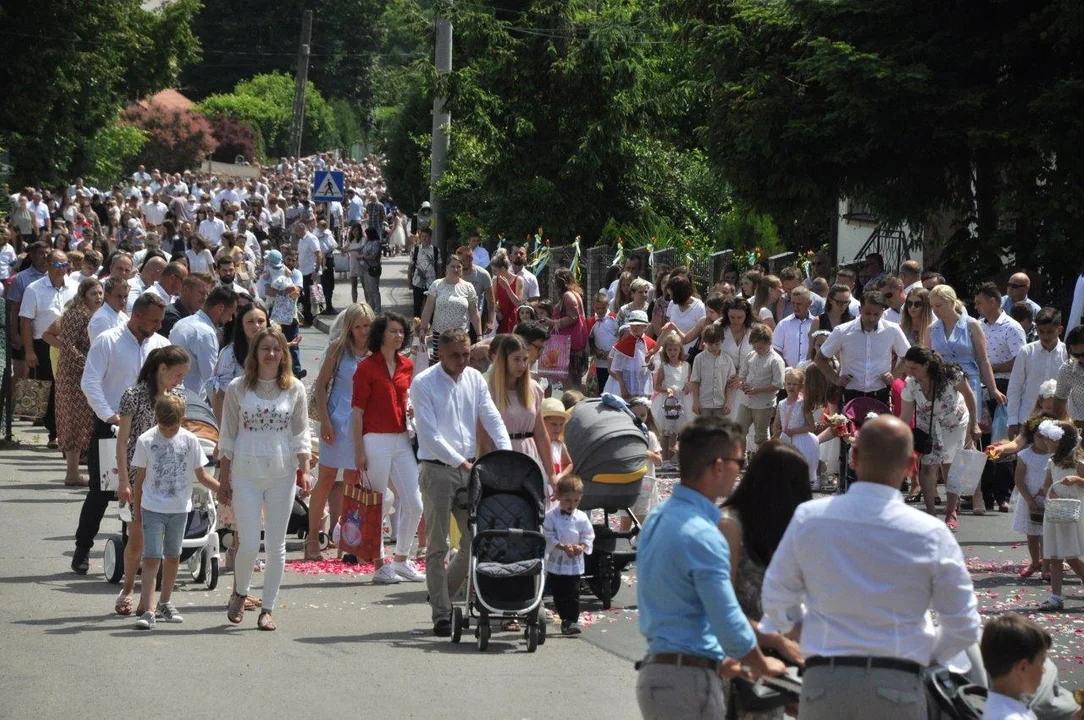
[481,335,557,497]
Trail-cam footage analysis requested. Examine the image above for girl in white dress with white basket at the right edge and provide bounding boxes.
[1038,420,1084,610]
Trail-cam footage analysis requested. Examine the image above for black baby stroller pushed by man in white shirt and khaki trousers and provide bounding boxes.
[452,450,545,653]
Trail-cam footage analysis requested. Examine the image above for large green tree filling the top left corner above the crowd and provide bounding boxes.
[0,0,199,184]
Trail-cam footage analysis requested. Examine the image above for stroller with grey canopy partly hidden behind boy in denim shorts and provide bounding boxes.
[102,390,221,590]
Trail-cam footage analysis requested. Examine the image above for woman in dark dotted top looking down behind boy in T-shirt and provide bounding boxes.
[114,345,191,615]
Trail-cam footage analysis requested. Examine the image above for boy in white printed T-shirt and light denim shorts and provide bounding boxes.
[132,395,218,630]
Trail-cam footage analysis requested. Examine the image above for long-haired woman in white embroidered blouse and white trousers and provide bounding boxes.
[219,329,312,630]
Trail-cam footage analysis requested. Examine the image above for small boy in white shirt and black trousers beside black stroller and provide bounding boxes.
[542,475,595,635]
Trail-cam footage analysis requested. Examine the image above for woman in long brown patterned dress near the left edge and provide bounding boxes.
[42,278,105,487]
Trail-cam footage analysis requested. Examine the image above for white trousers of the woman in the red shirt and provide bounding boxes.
[361,433,422,555]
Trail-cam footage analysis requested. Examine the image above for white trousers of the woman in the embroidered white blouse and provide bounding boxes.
[233,465,297,610]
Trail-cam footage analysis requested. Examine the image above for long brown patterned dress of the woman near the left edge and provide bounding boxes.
[55,303,94,452]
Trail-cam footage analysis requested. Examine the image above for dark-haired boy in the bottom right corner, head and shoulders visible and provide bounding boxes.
[980,613,1050,720]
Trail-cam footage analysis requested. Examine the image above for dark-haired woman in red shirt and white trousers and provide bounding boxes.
[353,312,425,584]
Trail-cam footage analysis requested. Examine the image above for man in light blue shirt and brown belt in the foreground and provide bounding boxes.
[636,416,785,720]
